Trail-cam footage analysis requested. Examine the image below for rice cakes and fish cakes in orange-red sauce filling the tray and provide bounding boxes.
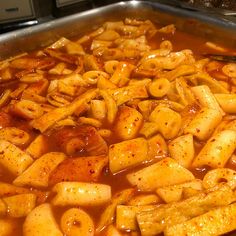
[0,18,236,236]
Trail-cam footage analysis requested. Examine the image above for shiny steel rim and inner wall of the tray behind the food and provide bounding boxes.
[0,1,236,59]
